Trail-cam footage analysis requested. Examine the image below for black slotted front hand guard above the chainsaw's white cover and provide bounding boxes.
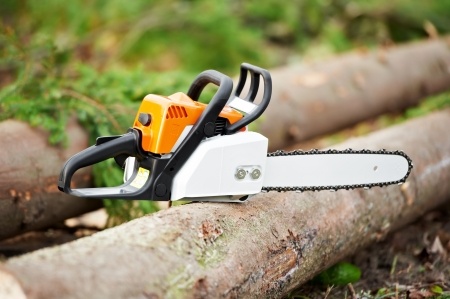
[225,63,272,135]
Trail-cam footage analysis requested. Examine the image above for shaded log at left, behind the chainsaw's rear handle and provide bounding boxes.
[0,120,101,239]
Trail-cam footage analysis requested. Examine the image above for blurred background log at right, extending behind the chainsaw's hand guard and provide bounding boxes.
[257,37,450,151]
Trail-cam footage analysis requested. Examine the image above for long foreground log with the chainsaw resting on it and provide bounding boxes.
[0,110,450,298]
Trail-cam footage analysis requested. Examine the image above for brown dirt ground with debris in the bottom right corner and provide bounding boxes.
[289,202,450,299]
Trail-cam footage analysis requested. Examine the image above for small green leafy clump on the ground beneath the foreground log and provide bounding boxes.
[313,262,361,286]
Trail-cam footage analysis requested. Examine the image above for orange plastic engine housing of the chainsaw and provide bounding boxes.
[133,92,245,154]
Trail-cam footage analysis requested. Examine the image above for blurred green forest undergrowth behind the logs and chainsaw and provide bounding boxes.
[0,0,450,224]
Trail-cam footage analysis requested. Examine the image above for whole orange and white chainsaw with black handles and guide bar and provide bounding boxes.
[58,63,413,202]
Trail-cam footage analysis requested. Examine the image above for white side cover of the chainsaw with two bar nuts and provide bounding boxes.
[170,131,268,201]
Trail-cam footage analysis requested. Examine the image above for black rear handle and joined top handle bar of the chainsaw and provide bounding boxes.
[58,70,233,200]
